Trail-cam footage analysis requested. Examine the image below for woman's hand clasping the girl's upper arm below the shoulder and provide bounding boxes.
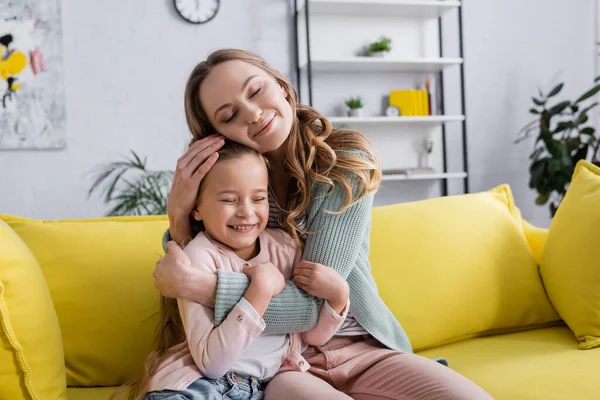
[152,241,217,308]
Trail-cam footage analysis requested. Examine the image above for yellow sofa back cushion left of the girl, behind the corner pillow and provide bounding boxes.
[5,216,168,386]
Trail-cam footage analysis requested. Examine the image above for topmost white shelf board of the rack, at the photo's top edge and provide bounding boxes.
[299,0,460,18]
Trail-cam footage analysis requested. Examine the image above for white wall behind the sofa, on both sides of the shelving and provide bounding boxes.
[0,0,595,226]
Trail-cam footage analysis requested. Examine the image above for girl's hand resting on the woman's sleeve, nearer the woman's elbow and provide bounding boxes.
[294,260,350,314]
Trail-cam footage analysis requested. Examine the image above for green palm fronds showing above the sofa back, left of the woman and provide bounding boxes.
[88,150,173,216]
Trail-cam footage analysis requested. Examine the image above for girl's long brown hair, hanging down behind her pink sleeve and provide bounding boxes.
[110,140,266,400]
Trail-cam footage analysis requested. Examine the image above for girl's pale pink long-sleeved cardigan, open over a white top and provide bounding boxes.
[148,228,349,392]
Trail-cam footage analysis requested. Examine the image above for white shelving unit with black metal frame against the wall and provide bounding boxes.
[294,0,469,203]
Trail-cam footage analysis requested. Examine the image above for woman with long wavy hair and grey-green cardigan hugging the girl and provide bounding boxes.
[155,50,490,400]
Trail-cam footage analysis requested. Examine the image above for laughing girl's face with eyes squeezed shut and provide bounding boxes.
[192,155,269,260]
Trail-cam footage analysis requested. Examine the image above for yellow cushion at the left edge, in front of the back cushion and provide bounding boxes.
[0,219,67,400]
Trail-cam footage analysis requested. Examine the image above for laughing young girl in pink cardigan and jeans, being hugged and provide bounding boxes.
[116,142,349,400]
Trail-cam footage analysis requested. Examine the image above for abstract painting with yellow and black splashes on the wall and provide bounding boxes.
[0,0,66,150]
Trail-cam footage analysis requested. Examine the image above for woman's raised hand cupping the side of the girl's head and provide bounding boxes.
[167,135,225,244]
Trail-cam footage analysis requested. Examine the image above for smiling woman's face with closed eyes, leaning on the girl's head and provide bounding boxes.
[200,60,293,153]
